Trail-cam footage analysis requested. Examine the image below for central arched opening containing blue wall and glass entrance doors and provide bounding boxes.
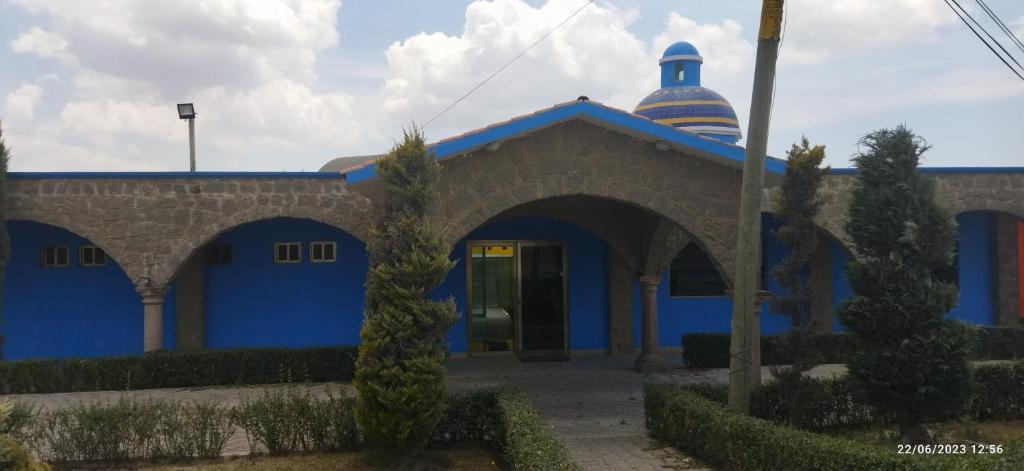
[434,215,609,355]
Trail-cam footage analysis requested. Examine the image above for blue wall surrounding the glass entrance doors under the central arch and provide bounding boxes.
[433,216,608,352]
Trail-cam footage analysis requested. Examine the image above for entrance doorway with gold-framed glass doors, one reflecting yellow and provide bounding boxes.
[467,241,568,356]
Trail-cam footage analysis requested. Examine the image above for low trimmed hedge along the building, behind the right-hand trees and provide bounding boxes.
[682,327,1024,368]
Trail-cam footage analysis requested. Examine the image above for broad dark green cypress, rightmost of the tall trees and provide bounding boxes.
[840,126,971,443]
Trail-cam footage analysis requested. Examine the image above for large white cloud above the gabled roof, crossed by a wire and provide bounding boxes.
[383,0,657,137]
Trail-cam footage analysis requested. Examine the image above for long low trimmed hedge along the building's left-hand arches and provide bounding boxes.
[0,346,358,394]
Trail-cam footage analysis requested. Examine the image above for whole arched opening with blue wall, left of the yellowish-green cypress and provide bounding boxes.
[165,217,367,348]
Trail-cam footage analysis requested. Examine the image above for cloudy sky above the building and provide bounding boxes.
[0,0,1024,171]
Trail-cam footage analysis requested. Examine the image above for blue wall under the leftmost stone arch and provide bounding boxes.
[0,221,142,359]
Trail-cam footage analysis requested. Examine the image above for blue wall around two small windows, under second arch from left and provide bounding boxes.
[206,218,367,348]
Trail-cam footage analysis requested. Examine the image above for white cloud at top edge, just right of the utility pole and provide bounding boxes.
[779,0,956,63]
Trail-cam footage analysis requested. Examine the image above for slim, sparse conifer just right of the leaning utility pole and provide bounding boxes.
[771,137,828,426]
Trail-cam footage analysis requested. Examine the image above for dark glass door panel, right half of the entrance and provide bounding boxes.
[519,243,565,353]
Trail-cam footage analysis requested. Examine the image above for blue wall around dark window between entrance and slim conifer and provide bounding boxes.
[633,214,790,347]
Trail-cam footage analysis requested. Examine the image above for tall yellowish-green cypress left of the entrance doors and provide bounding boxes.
[354,129,458,448]
